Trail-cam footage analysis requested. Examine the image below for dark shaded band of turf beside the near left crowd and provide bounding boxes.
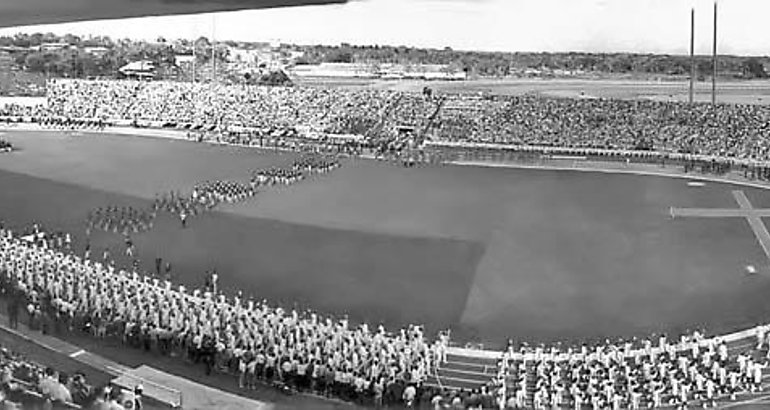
[0,171,482,329]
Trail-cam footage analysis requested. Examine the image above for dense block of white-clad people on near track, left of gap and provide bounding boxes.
[0,226,447,404]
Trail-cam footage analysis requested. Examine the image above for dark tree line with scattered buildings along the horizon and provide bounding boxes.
[0,33,770,80]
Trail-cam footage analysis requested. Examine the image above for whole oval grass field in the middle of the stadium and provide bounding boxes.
[0,132,770,350]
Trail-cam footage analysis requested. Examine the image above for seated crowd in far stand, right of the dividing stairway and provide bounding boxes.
[434,95,770,160]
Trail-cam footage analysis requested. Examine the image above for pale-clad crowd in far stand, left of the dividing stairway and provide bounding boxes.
[39,80,438,156]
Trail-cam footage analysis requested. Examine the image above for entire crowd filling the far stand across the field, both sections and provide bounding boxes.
[33,80,770,167]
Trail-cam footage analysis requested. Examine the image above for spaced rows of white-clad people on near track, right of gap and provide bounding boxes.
[500,326,770,410]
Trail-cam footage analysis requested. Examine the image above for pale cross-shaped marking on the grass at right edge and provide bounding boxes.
[671,191,770,261]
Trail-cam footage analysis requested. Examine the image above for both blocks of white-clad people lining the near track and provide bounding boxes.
[0,221,770,409]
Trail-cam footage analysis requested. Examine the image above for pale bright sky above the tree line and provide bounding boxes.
[0,0,770,55]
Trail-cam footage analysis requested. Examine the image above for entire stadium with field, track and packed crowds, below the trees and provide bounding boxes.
[0,0,770,409]
